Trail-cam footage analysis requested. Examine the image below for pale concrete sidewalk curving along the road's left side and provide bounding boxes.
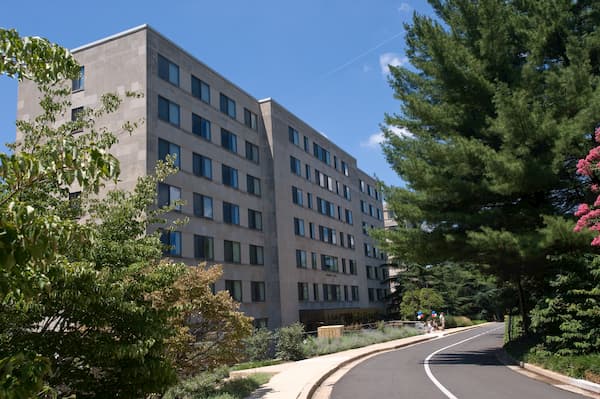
[231,325,481,399]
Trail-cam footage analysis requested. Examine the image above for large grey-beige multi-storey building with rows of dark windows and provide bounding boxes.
[17,25,389,328]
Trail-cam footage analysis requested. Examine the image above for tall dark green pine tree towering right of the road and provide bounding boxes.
[379,0,600,328]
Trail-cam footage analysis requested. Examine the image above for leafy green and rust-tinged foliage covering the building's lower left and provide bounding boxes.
[0,30,251,398]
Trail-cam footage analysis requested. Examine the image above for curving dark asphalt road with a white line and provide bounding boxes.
[331,323,584,399]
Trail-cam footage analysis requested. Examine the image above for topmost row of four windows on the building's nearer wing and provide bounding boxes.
[157,54,258,131]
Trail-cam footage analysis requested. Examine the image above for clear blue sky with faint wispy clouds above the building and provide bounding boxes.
[0,0,431,185]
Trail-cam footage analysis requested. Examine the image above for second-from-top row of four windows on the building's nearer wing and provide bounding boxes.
[158,104,260,164]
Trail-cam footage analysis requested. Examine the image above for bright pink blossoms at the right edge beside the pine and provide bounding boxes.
[574,127,600,246]
